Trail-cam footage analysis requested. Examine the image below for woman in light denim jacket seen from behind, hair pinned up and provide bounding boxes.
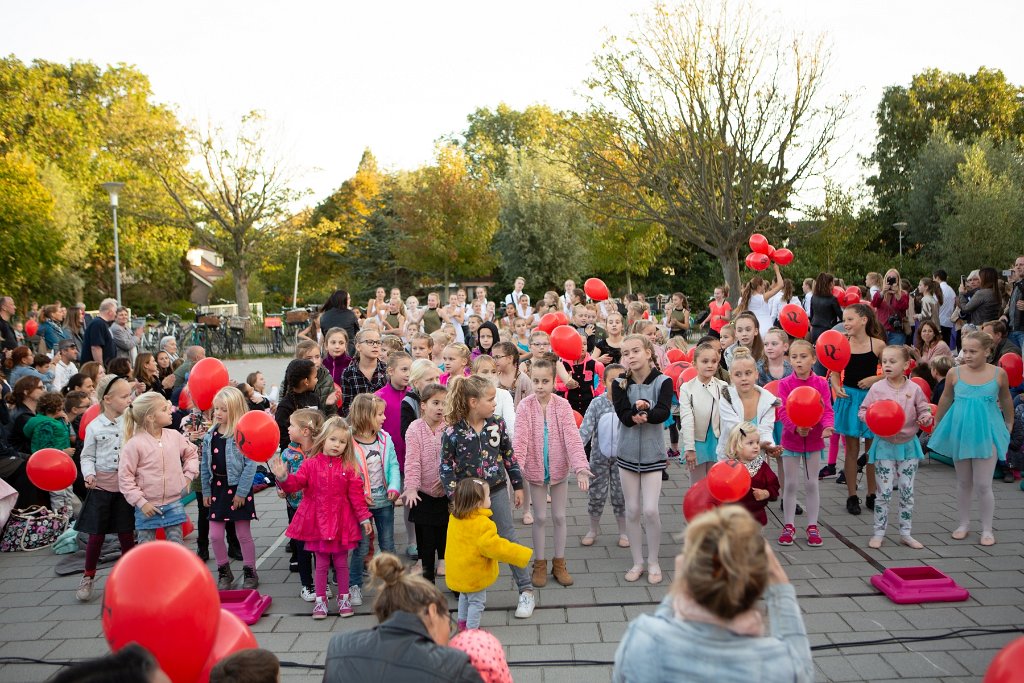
[612,505,814,683]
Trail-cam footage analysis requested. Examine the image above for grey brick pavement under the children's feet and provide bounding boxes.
[0,448,1024,683]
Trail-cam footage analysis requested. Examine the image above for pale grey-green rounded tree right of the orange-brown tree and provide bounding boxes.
[494,154,593,289]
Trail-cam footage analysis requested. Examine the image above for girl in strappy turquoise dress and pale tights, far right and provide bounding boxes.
[928,332,1014,546]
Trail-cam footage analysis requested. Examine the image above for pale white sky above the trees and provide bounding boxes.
[0,0,1024,210]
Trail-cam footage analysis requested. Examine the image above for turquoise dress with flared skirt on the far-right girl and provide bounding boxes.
[928,368,1010,461]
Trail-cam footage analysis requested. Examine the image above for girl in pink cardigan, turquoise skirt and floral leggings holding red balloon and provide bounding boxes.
[857,345,932,550]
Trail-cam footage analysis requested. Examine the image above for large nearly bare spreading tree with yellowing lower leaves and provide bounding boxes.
[568,2,847,297]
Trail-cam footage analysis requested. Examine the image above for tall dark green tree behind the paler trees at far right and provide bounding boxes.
[867,67,1024,225]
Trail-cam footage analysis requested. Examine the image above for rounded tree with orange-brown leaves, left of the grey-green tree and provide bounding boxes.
[394,144,498,290]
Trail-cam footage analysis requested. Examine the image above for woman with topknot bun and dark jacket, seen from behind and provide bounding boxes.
[324,553,482,683]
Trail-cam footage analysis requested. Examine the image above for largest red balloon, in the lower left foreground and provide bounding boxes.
[102,541,220,683]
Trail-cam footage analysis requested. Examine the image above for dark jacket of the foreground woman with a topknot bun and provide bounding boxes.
[324,611,482,683]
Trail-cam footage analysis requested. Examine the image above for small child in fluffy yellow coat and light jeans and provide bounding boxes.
[444,477,531,632]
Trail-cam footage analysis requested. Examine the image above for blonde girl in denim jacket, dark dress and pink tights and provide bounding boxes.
[200,387,260,591]
